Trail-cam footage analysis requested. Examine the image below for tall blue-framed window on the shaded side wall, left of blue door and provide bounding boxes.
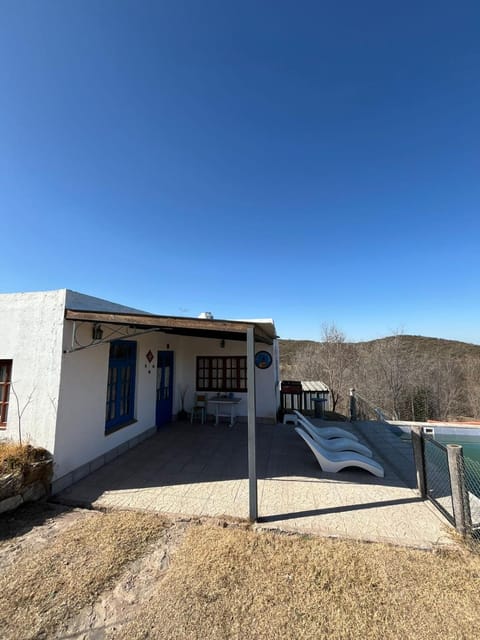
[105,340,137,433]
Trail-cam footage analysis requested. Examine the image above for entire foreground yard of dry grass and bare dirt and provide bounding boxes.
[0,503,480,640]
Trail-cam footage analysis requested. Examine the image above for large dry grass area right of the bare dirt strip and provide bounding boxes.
[118,527,480,640]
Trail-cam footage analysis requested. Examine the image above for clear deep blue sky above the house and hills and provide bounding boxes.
[0,0,480,343]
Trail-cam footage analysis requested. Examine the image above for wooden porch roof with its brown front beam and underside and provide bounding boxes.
[65,309,277,344]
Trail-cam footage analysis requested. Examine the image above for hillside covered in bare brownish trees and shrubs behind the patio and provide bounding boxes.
[280,336,480,420]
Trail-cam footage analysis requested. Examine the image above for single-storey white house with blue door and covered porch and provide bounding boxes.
[0,289,279,492]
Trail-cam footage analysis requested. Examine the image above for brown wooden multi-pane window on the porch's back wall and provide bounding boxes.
[197,356,247,391]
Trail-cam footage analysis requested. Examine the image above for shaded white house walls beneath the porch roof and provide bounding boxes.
[54,321,278,479]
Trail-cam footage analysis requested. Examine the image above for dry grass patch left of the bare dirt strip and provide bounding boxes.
[0,512,166,640]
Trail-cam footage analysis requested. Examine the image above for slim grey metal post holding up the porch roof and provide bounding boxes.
[247,327,258,522]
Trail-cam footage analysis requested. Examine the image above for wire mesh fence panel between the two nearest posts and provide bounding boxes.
[423,435,455,523]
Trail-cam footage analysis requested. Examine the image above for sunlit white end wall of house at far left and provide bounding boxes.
[0,289,65,454]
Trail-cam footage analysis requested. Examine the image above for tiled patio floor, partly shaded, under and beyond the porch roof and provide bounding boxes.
[57,423,451,547]
